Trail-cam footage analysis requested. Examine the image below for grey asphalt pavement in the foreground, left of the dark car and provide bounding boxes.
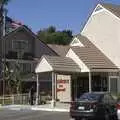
[0,110,70,120]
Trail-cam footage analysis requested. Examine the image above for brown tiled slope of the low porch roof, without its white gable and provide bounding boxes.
[39,56,81,73]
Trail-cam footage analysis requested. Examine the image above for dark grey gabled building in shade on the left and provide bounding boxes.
[0,25,57,94]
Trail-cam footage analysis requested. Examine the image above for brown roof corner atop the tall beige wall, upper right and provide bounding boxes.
[101,3,120,18]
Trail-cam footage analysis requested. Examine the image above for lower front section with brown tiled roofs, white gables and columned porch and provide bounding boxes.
[35,35,119,102]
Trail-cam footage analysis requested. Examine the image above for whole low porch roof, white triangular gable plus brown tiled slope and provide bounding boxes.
[35,56,81,73]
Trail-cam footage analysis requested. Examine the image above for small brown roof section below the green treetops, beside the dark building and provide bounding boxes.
[48,44,70,57]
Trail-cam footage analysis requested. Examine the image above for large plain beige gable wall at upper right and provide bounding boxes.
[81,10,120,68]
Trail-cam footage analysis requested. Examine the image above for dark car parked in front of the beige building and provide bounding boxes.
[70,92,117,120]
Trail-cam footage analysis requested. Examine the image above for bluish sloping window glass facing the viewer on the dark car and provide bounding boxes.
[78,93,101,101]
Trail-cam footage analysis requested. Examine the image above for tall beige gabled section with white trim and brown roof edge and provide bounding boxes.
[81,3,120,92]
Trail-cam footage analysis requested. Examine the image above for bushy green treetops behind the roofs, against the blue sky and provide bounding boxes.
[37,26,72,45]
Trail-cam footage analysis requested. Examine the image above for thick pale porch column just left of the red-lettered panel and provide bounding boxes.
[51,72,55,108]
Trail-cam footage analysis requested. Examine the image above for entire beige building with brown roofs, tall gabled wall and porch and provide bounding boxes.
[35,4,120,102]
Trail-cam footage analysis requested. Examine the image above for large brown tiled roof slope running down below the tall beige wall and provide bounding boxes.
[72,35,117,69]
